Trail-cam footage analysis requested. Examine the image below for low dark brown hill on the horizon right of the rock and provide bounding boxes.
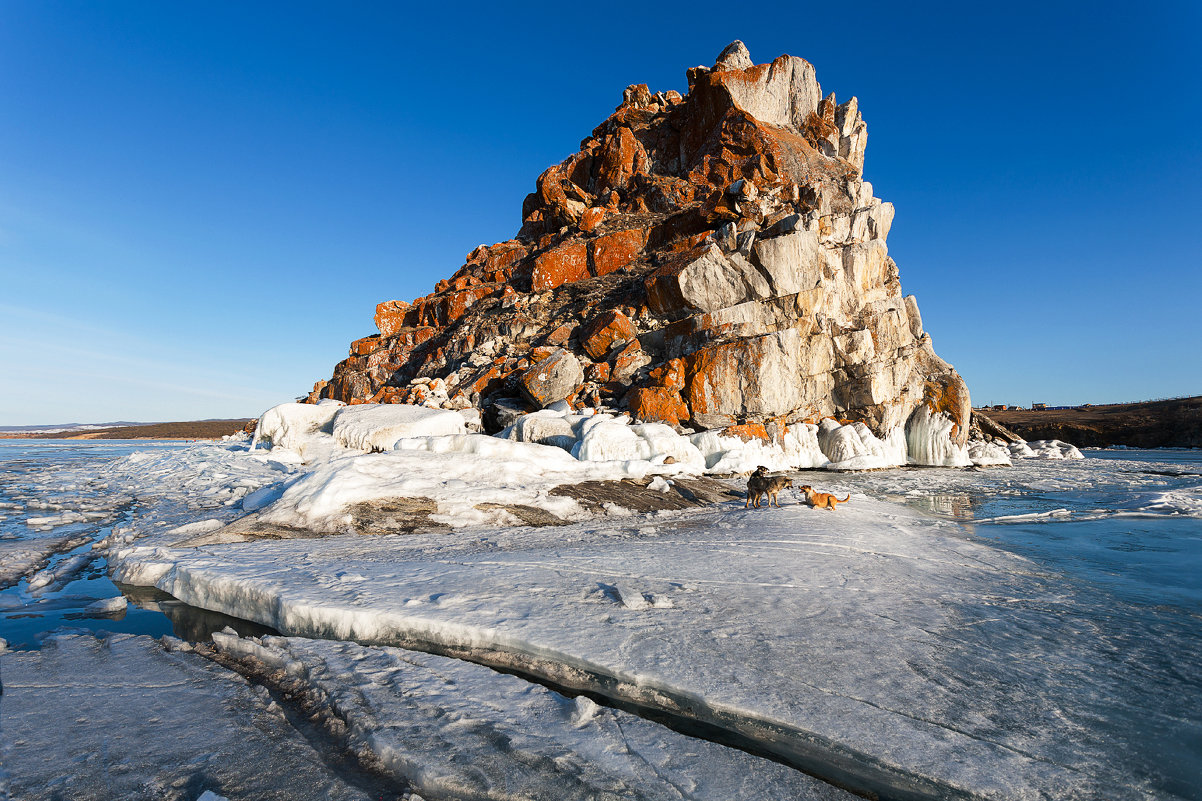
[984,396,1202,447]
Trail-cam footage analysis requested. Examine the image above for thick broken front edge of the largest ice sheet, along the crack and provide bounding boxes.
[114,548,1052,801]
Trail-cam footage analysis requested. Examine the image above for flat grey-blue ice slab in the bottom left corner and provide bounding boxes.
[0,635,389,801]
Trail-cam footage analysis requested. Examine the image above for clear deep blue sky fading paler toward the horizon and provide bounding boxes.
[0,0,1202,425]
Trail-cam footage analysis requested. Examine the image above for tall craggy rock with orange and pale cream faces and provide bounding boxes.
[310,42,970,462]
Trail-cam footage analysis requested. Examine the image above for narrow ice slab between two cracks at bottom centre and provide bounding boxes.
[214,634,853,801]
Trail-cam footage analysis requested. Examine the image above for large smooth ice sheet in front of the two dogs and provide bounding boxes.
[110,493,1173,799]
